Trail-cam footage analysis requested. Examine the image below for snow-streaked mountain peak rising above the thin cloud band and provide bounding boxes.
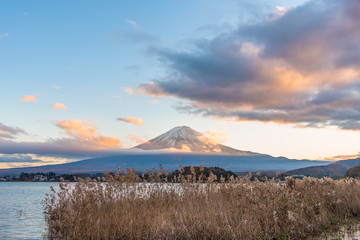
[134,126,259,155]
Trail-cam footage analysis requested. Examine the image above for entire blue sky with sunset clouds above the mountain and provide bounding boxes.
[0,0,360,168]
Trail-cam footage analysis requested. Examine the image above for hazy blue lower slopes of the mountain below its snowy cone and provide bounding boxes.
[0,153,330,176]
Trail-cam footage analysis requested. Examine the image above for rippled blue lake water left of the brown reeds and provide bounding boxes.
[0,182,58,239]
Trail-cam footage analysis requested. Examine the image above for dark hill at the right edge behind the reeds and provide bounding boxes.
[284,158,360,177]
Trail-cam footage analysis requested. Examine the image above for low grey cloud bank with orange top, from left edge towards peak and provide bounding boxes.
[0,120,122,157]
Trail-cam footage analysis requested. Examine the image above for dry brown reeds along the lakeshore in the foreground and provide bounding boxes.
[44,168,360,239]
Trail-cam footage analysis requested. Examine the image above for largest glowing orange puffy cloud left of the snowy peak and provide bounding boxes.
[56,120,120,148]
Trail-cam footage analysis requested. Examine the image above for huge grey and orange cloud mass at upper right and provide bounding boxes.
[132,0,360,130]
